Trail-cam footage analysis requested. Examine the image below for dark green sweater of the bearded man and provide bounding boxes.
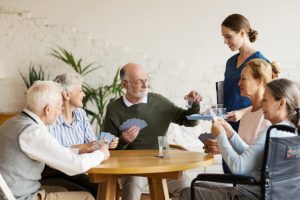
[104,93,200,149]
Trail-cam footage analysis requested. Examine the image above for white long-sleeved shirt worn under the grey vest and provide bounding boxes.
[19,109,104,176]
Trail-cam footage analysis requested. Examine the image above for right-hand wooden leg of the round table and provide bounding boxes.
[148,178,170,200]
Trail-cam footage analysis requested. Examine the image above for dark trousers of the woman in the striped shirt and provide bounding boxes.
[41,166,98,198]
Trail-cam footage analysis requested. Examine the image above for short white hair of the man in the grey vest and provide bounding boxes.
[26,81,62,113]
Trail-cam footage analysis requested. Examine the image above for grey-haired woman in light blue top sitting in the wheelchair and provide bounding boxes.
[180,79,300,200]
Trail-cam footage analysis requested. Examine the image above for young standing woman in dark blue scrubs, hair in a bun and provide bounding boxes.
[221,14,268,131]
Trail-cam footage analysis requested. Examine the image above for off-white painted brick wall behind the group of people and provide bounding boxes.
[0,0,300,128]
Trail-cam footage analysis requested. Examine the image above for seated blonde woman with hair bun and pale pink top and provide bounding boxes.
[204,59,279,155]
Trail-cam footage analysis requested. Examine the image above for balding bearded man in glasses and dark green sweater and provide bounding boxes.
[104,63,202,200]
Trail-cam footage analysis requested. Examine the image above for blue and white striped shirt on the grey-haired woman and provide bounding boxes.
[48,108,97,147]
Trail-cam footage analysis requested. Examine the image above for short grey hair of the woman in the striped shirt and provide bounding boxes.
[54,72,83,92]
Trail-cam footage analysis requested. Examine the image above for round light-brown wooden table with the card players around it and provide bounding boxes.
[88,150,214,200]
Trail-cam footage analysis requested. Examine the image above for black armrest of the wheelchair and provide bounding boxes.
[193,174,259,185]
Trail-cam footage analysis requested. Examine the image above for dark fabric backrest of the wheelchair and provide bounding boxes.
[261,125,300,200]
